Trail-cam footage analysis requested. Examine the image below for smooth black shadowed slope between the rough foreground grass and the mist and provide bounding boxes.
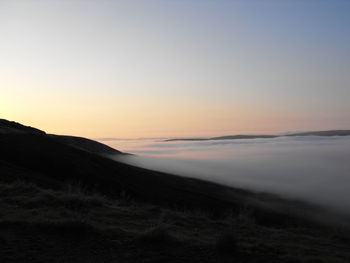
[0,119,344,225]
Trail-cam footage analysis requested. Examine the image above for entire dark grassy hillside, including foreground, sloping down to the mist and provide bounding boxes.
[0,121,350,262]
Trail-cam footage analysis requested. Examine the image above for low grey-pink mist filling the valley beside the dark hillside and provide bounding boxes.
[106,136,350,214]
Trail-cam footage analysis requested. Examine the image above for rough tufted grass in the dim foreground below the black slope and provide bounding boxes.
[0,181,350,263]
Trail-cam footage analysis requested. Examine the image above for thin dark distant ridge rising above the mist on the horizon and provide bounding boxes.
[164,130,350,142]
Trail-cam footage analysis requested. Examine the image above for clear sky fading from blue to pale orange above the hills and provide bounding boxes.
[0,0,350,138]
